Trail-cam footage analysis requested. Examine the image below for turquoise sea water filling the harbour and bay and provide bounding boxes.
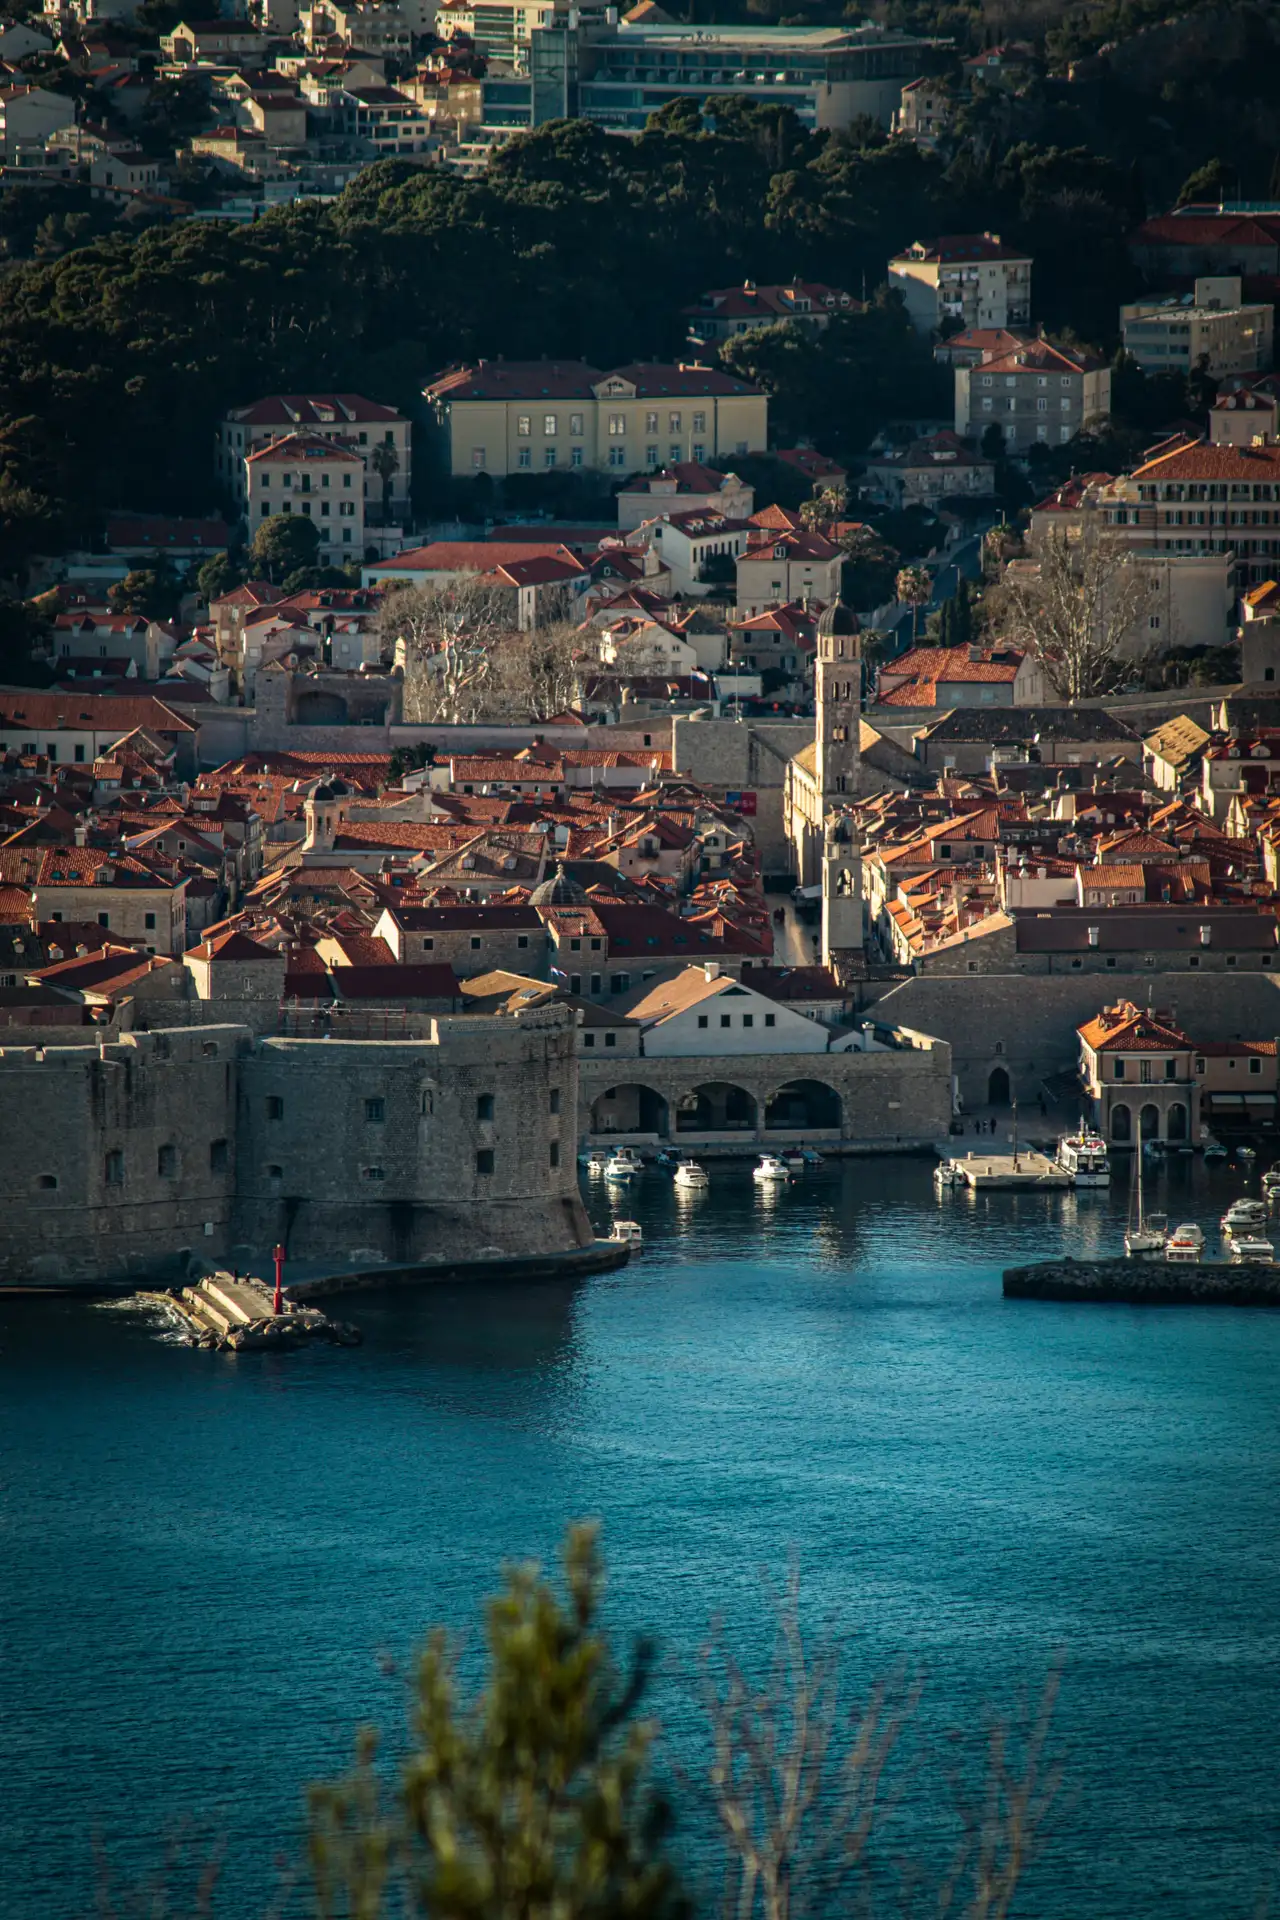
[0,1158,1280,1920]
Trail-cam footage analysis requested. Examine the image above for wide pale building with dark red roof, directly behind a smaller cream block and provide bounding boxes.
[217,394,413,520]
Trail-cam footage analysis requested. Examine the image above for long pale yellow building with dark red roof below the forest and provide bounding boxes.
[424,361,770,478]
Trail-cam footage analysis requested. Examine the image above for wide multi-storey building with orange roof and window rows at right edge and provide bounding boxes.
[1100,440,1280,586]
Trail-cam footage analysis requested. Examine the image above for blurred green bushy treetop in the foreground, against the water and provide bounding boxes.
[311,1526,689,1920]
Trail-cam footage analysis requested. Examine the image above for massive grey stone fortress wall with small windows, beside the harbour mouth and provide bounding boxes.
[0,1006,591,1286]
